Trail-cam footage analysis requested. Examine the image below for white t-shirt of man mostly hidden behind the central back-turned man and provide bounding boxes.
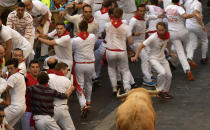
[94,10,109,37]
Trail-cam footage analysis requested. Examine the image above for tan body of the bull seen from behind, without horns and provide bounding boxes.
[116,88,156,130]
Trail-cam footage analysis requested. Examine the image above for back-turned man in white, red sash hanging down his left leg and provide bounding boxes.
[71,20,96,118]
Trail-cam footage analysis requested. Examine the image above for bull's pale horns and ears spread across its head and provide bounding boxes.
[117,88,158,99]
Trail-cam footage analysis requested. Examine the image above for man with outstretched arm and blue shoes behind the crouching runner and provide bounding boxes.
[129,4,162,86]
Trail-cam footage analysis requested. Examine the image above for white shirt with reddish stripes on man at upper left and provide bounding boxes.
[7,11,33,40]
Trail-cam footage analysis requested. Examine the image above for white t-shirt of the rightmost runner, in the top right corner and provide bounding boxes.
[184,0,202,26]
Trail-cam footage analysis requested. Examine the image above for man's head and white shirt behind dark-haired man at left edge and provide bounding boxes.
[12,48,27,77]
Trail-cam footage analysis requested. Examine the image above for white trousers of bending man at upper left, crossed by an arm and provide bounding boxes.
[41,21,50,56]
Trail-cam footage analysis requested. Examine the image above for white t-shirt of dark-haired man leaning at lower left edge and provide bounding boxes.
[7,72,26,106]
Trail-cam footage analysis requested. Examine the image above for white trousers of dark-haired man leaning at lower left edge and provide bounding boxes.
[4,105,26,127]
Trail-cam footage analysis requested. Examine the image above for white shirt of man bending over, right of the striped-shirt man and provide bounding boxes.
[29,1,51,27]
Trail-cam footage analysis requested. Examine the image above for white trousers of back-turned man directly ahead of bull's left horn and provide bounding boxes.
[106,50,131,89]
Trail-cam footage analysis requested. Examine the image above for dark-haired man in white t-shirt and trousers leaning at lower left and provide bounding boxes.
[4,58,26,127]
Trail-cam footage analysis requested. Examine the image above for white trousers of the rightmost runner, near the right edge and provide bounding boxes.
[186,24,208,59]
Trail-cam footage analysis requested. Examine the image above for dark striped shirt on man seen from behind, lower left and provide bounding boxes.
[27,85,67,116]
